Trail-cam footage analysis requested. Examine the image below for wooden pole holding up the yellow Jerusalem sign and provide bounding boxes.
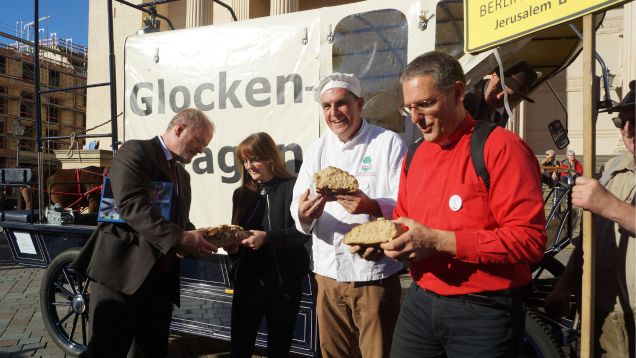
[581,14,596,357]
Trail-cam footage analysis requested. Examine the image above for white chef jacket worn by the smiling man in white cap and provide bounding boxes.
[290,119,406,282]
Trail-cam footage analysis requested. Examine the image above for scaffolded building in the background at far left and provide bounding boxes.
[0,41,86,168]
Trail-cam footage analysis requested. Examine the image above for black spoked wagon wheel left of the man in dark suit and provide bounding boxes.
[40,248,89,356]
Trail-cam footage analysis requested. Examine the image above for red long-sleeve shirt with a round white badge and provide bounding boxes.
[394,115,546,295]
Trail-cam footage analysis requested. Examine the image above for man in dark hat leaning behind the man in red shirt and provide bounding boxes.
[464,61,538,127]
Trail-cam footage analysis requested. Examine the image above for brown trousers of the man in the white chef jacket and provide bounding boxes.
[316,273,401,358]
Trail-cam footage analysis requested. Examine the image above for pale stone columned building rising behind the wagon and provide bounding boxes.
[88,0,636,165]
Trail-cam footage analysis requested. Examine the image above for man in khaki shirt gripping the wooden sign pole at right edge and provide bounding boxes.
[546,80,636,357]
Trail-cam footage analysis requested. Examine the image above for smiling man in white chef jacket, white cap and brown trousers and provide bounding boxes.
[290,73,406,358]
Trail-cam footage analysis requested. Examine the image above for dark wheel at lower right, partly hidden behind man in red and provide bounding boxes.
[518,312,565,358]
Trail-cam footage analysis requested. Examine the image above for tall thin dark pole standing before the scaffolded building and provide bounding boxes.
[33,0,44,223]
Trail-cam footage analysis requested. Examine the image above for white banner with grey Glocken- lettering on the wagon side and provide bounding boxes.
[125,11,320,227]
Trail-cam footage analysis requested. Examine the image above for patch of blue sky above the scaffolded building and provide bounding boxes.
[0,0,88,46]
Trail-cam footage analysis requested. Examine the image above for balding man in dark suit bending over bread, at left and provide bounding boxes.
[73,109,217,358]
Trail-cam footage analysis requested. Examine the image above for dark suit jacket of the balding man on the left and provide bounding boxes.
[73,137,194,304]
